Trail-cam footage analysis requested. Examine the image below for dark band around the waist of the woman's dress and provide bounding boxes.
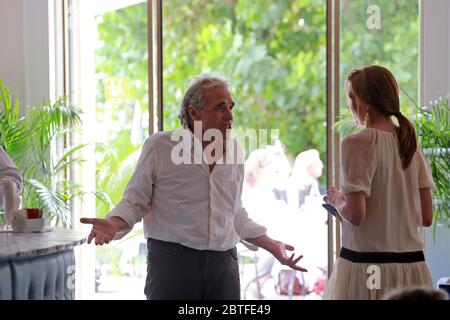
[340,247,425,263]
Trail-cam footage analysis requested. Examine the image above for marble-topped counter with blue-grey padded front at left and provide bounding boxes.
[0,228,85,300]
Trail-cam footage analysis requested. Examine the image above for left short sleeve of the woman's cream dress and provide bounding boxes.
[341,133,377,197]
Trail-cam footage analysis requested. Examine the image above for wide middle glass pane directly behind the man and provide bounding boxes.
[163,0,327,299]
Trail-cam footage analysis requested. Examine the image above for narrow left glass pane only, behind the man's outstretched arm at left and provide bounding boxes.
[92,0,149,299]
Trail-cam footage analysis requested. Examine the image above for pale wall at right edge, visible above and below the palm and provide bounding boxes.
[421,0,450,283]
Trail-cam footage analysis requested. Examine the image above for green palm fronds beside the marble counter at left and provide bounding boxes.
[0,80,84,227]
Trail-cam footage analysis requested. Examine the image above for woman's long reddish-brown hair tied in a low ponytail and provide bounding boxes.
[347,65,417,169]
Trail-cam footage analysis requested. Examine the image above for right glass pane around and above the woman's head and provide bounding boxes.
[340,0,419,131]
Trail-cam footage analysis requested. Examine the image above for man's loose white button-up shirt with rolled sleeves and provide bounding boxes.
[108,129,266,251]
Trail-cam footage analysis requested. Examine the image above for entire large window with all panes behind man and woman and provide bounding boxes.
[64,0,419,298]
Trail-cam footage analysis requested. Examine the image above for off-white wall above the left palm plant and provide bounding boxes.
[0,0,51,108]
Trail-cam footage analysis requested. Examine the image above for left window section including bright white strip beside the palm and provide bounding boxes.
[68,0,149,299]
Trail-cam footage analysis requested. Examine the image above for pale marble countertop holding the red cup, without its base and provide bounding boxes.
[0,227,86,261]
